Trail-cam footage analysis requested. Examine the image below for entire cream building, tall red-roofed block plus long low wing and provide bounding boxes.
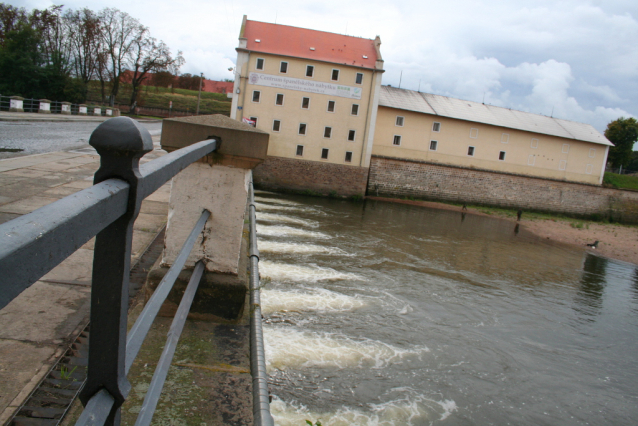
[231,16,613,195]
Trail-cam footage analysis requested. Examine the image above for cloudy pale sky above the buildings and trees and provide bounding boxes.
[10,0,638,132]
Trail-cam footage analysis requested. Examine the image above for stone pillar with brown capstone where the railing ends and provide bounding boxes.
[159,115,269,321]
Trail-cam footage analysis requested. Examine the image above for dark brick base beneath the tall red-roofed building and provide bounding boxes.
[253,157,368,196]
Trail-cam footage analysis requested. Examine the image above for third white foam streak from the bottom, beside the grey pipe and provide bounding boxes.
[261,288,365,314]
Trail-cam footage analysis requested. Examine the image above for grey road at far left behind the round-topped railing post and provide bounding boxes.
[0,120,162,159]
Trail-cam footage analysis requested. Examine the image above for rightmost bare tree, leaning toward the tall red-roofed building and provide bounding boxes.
[130,35,184,109]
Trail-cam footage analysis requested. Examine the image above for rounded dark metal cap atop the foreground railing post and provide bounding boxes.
[89,117,153,157]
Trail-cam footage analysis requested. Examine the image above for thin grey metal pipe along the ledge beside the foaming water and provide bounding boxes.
[248,176,275,426]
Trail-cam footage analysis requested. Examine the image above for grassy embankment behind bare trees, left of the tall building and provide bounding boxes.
[87,81,231,115]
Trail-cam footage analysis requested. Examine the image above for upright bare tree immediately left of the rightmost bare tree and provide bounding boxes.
[100,8,148,105]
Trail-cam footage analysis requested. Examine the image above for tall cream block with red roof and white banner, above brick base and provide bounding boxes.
[231,16,383,171]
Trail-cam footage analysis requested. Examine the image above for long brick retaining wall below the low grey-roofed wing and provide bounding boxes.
[368,156,638,223]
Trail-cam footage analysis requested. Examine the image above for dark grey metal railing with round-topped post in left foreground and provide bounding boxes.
[0,117,235,425]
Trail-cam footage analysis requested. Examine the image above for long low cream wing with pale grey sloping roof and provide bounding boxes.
[372,86,612,184]
